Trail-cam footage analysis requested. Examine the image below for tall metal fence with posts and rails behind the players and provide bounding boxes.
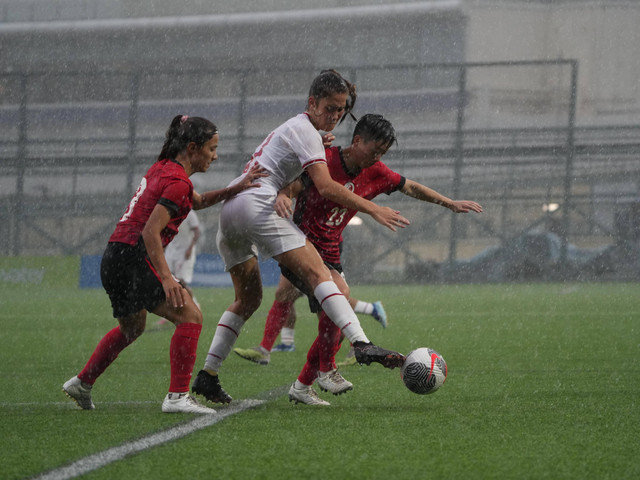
[0,60,640,282]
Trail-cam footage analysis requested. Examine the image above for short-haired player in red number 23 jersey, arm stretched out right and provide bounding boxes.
[240,114,482,405]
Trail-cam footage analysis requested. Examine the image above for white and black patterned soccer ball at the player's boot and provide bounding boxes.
[400,347,447,395]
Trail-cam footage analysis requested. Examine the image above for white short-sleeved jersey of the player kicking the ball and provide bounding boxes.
[231,113,327,195]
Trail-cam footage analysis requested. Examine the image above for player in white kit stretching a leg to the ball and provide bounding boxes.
[192,70,409,403]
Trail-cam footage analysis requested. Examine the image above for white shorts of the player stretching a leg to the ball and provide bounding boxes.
[216,194,306,271]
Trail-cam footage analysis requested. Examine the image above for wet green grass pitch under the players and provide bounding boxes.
[0,258,640,480]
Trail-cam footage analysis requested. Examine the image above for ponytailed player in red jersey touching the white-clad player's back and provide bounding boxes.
[62,115,265,413]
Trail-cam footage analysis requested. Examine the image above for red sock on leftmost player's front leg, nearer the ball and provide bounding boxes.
[169,323,202,393]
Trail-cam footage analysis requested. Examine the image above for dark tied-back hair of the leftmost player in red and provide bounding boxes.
[158,115,218,160]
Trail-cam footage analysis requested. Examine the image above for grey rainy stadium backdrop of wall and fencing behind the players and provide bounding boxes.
[0,0,640,283]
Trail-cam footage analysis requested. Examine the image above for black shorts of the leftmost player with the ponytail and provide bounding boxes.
[100,242,166,318]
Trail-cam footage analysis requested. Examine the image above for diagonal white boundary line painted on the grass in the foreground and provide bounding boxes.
[28,399,266,480]
